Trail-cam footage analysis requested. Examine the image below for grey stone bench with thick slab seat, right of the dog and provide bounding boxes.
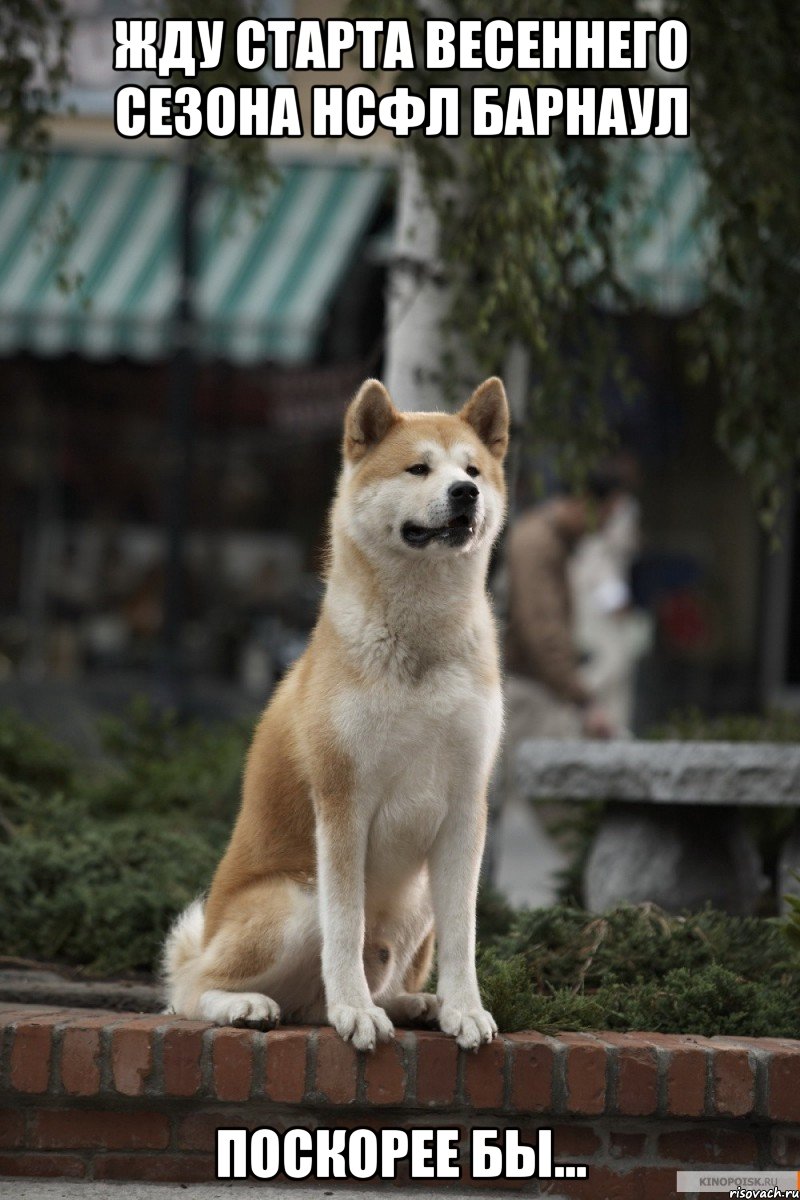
[517,740,800,914]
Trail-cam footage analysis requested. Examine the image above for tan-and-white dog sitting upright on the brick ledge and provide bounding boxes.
[163,378,509,1050]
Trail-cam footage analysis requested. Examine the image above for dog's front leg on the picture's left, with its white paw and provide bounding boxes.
[317,810,393,1050]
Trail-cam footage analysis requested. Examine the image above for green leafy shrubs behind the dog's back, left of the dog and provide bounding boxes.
[0,702,247,973]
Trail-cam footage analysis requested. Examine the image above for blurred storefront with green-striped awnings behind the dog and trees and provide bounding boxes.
[0,0,800,727]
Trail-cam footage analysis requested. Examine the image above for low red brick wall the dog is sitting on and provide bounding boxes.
[0,1004,800,1200]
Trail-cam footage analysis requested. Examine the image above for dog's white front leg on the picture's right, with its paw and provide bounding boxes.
[428,794,498,1050]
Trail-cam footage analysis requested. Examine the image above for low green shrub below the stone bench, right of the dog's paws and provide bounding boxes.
[479,905,800,1037]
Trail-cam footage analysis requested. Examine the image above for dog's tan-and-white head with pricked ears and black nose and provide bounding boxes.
[339,378,509,558]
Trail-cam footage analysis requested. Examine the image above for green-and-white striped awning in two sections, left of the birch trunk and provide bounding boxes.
[0,154,387,364]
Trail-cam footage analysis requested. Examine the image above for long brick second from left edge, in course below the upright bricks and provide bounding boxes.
[30,1109,169,1150]
